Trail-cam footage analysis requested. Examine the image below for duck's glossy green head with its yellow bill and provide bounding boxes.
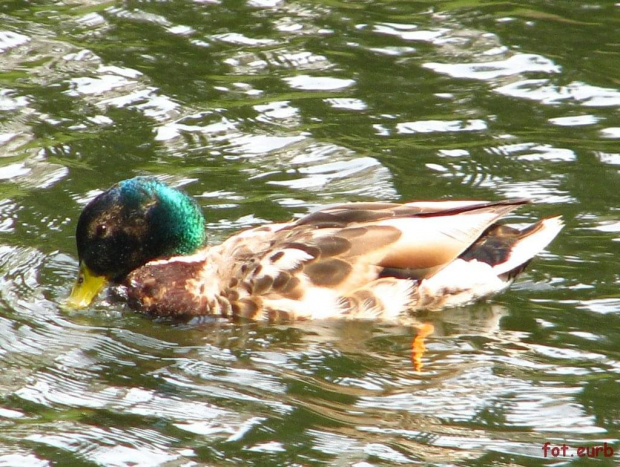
[68,177,206,308]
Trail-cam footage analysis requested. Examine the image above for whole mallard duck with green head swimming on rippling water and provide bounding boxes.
[68,176,563,320]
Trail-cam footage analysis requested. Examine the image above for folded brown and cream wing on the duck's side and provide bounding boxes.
[235,200,526,299]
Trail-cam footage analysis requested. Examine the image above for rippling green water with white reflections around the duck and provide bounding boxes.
[0,0,620,466]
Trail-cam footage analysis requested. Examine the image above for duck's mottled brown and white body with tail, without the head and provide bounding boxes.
[125,200,561,319]
